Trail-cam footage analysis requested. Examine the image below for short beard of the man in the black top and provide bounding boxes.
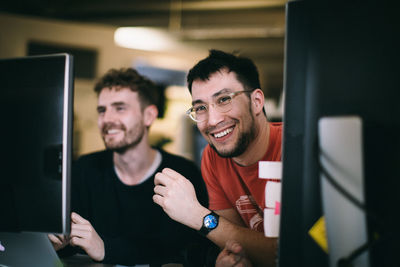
[102,124,145,154]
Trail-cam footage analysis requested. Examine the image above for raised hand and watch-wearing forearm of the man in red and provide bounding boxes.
[153,169,277,267]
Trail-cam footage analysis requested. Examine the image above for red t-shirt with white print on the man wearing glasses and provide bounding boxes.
[201,123,282,232]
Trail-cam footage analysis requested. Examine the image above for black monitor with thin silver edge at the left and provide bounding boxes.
[0,54,73,233]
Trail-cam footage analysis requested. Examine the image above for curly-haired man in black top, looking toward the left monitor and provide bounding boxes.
[49,68,209,266]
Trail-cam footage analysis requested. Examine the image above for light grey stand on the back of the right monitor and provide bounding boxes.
[318,116,369,267]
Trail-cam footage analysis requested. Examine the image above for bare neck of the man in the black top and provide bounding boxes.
[113,144,157,185]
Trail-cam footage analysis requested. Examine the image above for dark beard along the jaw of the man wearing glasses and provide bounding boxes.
[209,112,256,158]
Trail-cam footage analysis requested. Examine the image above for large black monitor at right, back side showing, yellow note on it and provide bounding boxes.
[278,1,400,267]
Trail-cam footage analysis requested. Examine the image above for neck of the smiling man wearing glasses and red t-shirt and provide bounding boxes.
[233,117,270,166]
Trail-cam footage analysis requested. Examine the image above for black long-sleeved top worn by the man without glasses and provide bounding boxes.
[61,150,210,265]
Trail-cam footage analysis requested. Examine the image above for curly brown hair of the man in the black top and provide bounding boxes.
[94,68,160,109]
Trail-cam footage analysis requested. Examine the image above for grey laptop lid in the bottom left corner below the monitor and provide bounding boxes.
[0,232,63,267]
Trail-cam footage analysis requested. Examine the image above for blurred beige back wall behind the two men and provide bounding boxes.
[0,13,207,158]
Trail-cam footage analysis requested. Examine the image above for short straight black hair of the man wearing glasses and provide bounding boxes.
[187,49,261,93]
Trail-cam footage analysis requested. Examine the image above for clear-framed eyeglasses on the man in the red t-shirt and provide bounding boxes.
[186,90,253,122]
